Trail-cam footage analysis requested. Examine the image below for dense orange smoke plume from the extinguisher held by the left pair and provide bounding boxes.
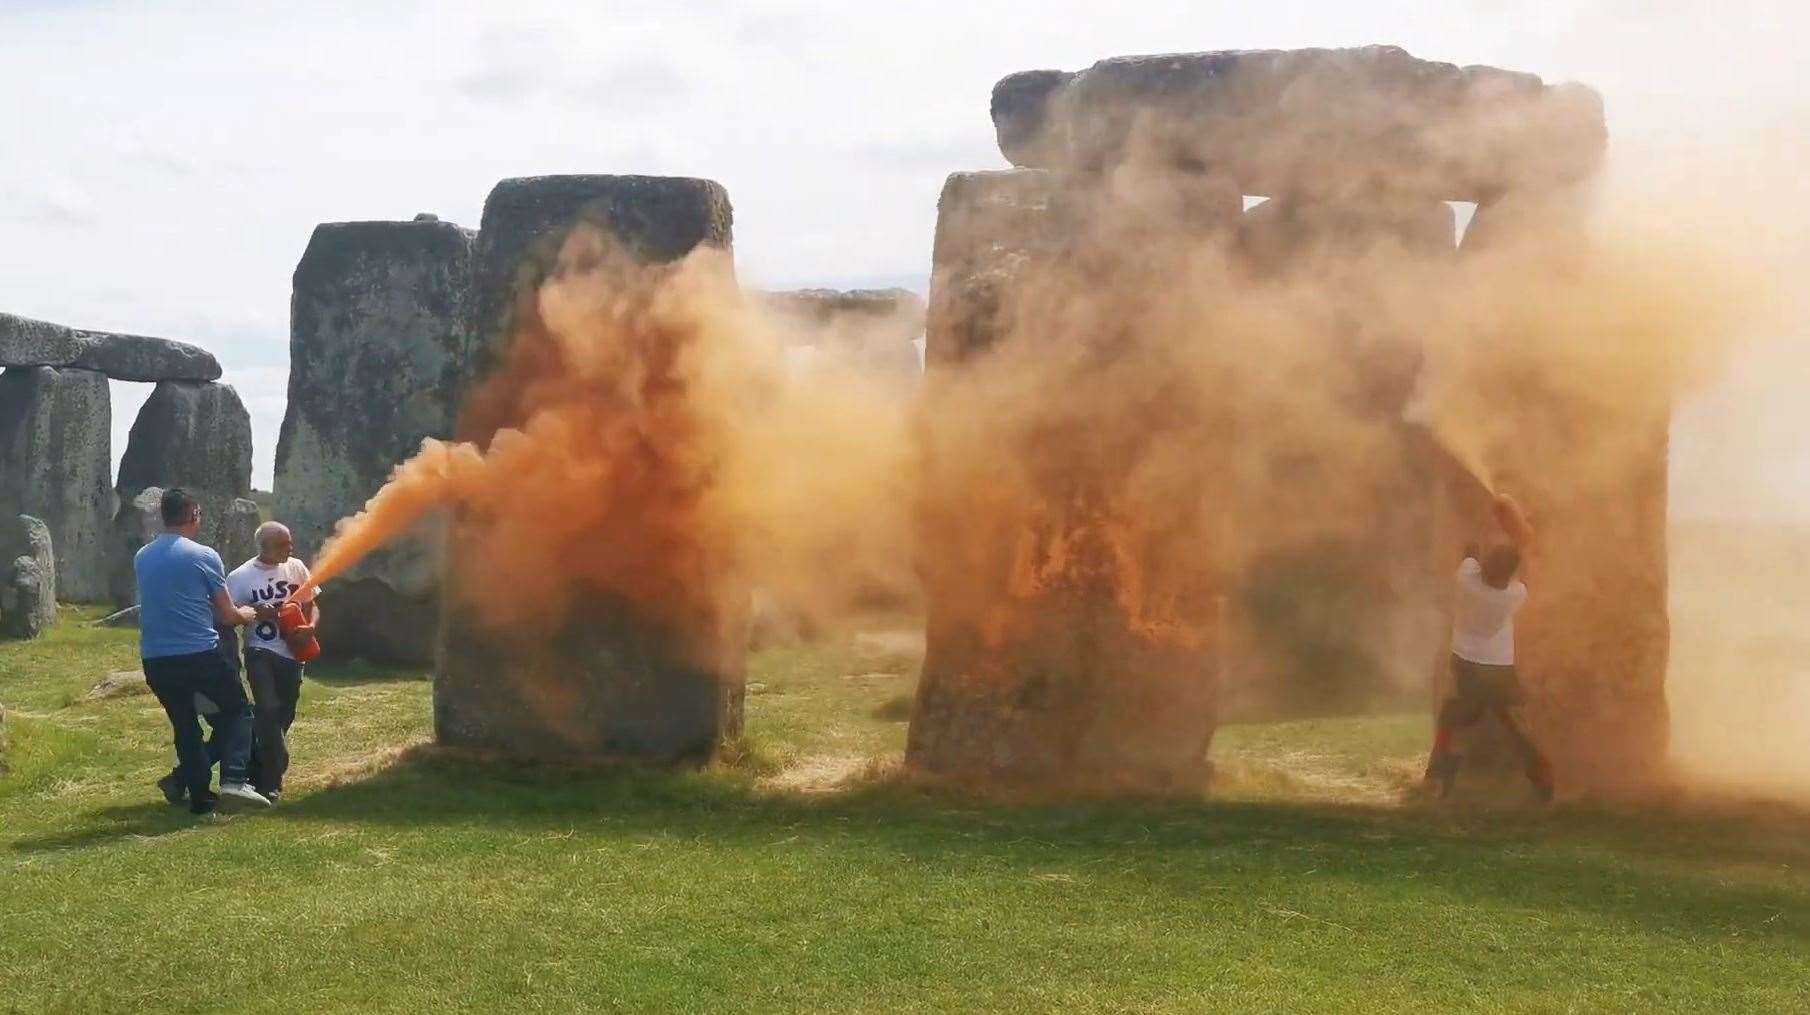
[300,226,910,635]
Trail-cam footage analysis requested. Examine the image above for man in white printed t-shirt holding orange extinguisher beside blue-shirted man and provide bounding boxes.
[226,521,320,803]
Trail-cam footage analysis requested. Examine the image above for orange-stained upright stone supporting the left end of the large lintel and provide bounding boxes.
[907,170,1240,787]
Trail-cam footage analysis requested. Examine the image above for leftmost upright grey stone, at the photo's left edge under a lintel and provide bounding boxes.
[0,367,114,602]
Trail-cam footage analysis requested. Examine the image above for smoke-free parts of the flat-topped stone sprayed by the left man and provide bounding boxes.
[434,175,746,760]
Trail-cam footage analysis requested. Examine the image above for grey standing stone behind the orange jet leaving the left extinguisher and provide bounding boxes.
[275,217,474,666]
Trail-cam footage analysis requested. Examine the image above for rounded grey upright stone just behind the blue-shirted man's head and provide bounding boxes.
[118,380,252,550]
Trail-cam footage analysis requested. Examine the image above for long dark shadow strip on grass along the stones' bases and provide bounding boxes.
[244,747,1810,943]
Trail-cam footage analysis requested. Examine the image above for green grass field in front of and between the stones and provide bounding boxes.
[0,613,1810,1013]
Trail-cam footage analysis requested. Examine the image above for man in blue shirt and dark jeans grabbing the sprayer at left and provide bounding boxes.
[132,487,270,814]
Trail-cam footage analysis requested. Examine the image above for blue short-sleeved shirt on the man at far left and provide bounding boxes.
[132,532,226,659]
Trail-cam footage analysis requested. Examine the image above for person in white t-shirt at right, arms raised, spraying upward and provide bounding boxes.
[1426,524,1553,802]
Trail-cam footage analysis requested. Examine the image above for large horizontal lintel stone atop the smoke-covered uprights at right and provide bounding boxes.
[994,45,1607,201]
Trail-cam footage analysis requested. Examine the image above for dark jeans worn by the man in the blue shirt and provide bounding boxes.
[145,651,252,800]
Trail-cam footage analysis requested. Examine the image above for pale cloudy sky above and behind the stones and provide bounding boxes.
[0,0,1810,519]
